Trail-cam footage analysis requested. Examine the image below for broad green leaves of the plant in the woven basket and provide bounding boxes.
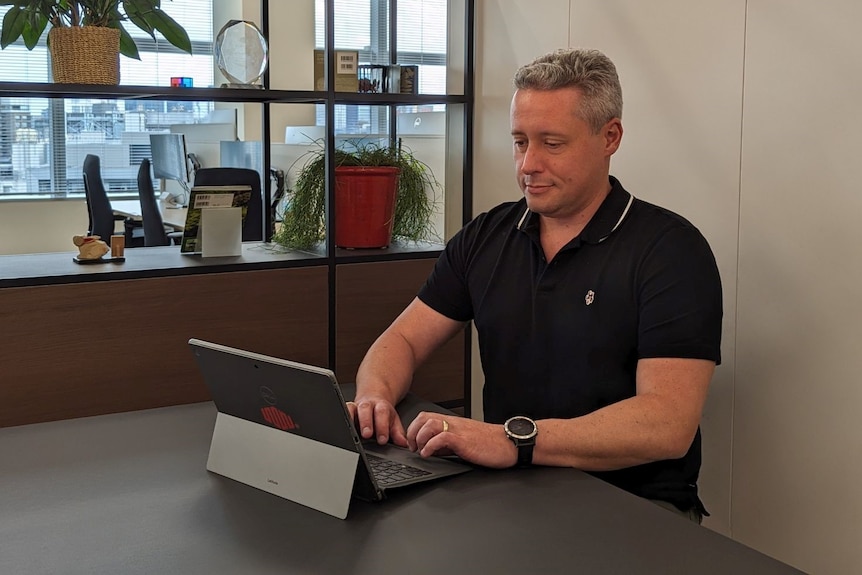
[0,0,192,60]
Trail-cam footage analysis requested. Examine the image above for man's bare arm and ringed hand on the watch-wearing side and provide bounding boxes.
[407,358,715,471]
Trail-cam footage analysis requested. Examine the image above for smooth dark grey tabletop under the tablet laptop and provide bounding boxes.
[0,403,798,575]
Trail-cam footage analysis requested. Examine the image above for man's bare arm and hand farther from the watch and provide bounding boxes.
[349,298,464,446]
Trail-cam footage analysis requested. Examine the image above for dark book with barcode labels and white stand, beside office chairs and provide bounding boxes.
[180,186,252,256]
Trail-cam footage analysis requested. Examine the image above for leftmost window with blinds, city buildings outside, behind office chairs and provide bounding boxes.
[0,0,214,197]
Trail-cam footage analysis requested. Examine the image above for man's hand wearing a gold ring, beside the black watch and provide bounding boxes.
[407,411,518,469]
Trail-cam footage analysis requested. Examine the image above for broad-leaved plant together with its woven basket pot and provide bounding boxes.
[0,0,192,84]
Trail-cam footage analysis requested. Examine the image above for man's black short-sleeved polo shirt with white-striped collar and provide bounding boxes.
[419,177,722,509]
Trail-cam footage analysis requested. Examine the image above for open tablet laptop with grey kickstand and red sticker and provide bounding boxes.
[189,339,471,519]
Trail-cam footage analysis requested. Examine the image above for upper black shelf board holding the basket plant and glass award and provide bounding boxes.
[0,82,466,106]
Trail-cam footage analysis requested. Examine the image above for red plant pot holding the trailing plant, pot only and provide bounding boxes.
[335,166,401,248]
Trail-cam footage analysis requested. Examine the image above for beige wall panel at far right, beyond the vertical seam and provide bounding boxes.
[732,0,862,574]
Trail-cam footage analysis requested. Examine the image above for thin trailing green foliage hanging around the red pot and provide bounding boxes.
[272,141,440,249]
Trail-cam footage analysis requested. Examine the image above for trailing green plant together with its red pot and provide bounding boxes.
[273,141,440,249]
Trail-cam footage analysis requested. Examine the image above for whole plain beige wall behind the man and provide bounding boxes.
[474,0,862,574]
